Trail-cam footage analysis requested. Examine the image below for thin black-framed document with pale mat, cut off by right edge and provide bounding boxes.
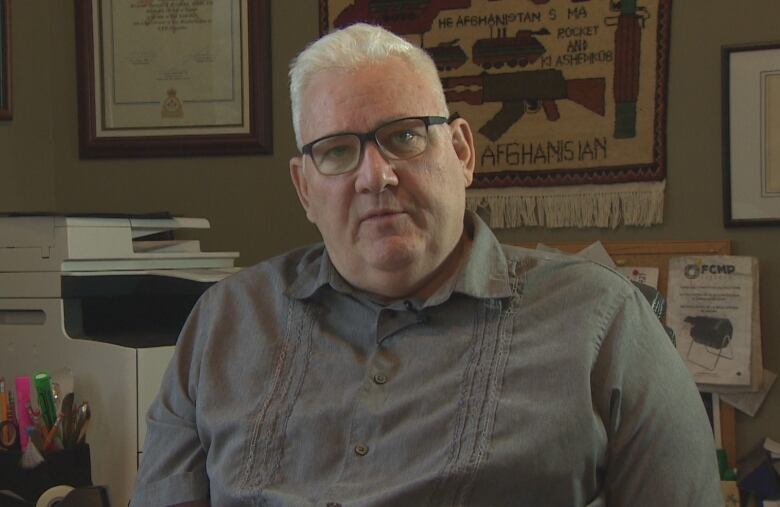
[721,42,780,225]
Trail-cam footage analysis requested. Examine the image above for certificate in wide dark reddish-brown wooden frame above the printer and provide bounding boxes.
[75,0,272,158]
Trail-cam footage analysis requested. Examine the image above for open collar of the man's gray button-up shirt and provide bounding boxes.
[286,211,512,306]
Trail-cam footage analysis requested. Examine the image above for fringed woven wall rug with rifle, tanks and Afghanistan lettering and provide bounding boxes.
[320,0,671,227]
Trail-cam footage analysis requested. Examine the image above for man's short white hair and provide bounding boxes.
[290,23,449,149]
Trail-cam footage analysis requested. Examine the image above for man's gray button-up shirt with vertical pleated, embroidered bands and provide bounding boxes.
[132,214,722,507]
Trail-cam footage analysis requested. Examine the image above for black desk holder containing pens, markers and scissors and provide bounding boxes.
[0,444,92,503]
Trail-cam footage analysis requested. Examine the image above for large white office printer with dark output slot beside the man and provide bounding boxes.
[0,215,238,506]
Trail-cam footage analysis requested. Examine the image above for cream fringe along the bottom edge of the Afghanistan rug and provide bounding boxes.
[466,181,666,229]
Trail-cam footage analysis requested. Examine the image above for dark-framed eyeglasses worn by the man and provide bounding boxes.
[301,116,455,176]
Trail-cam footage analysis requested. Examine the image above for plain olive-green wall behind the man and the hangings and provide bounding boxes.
[0,0,780,460]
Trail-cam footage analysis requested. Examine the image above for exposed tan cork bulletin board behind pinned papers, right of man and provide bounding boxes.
[517,240,737,467]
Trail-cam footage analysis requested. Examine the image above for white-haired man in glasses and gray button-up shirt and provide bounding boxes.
[133,25,722,507]
